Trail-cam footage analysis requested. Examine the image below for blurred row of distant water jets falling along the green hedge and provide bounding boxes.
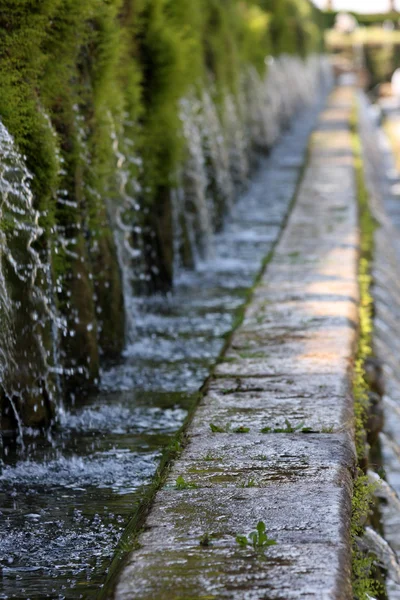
[173,56,332,273]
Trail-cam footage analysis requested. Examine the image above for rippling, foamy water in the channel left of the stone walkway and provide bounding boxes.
[0,59,330,600]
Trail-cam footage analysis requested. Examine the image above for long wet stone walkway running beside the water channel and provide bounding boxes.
[116,88,358,600]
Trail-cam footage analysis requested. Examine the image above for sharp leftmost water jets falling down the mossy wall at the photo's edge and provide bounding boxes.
[0,122,58,439]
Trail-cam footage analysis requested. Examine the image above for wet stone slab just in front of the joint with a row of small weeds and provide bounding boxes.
[166,434,354,491]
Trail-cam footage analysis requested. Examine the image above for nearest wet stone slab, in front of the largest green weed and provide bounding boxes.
[120,544,350,600]
